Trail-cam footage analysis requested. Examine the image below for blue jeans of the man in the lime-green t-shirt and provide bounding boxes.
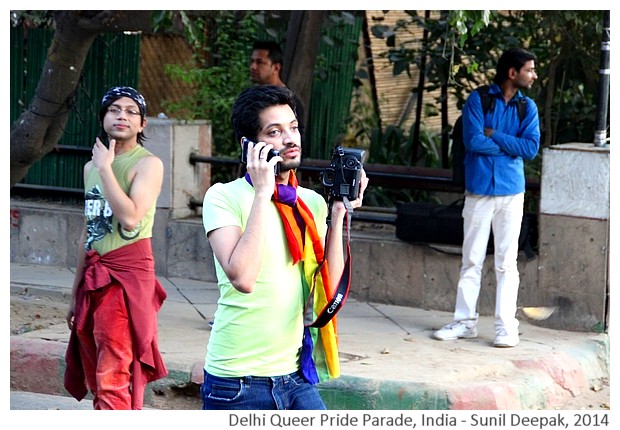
[200,371,326,410]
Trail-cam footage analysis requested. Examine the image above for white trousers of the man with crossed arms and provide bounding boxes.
[454,193,524,334]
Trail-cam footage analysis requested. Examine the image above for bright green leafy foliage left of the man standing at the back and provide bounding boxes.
[153,10,292,182]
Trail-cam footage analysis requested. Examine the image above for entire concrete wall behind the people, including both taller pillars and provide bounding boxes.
[10,119,610,331]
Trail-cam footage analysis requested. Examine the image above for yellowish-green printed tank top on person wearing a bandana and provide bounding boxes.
[84,145,157,255]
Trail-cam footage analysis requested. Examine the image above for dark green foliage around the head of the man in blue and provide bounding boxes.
[371,10,603,146]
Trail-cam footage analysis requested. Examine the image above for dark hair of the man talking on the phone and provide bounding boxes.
[230,85,297,141]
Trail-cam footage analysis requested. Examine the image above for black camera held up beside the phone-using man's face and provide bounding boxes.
[321,146,366,200]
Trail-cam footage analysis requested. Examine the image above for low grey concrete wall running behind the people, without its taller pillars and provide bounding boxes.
[11,199,538,315]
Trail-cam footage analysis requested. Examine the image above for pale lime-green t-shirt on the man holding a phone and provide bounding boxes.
[202,178,327,377]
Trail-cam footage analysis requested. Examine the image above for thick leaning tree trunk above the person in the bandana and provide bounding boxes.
[11,10,150,187]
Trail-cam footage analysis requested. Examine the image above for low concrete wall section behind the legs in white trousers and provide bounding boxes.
[351,229,538,315]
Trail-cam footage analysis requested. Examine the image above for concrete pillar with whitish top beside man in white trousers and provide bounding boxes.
[538,143,610,331]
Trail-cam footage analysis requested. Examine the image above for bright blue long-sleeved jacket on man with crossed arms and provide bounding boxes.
[462,84,540,196]
